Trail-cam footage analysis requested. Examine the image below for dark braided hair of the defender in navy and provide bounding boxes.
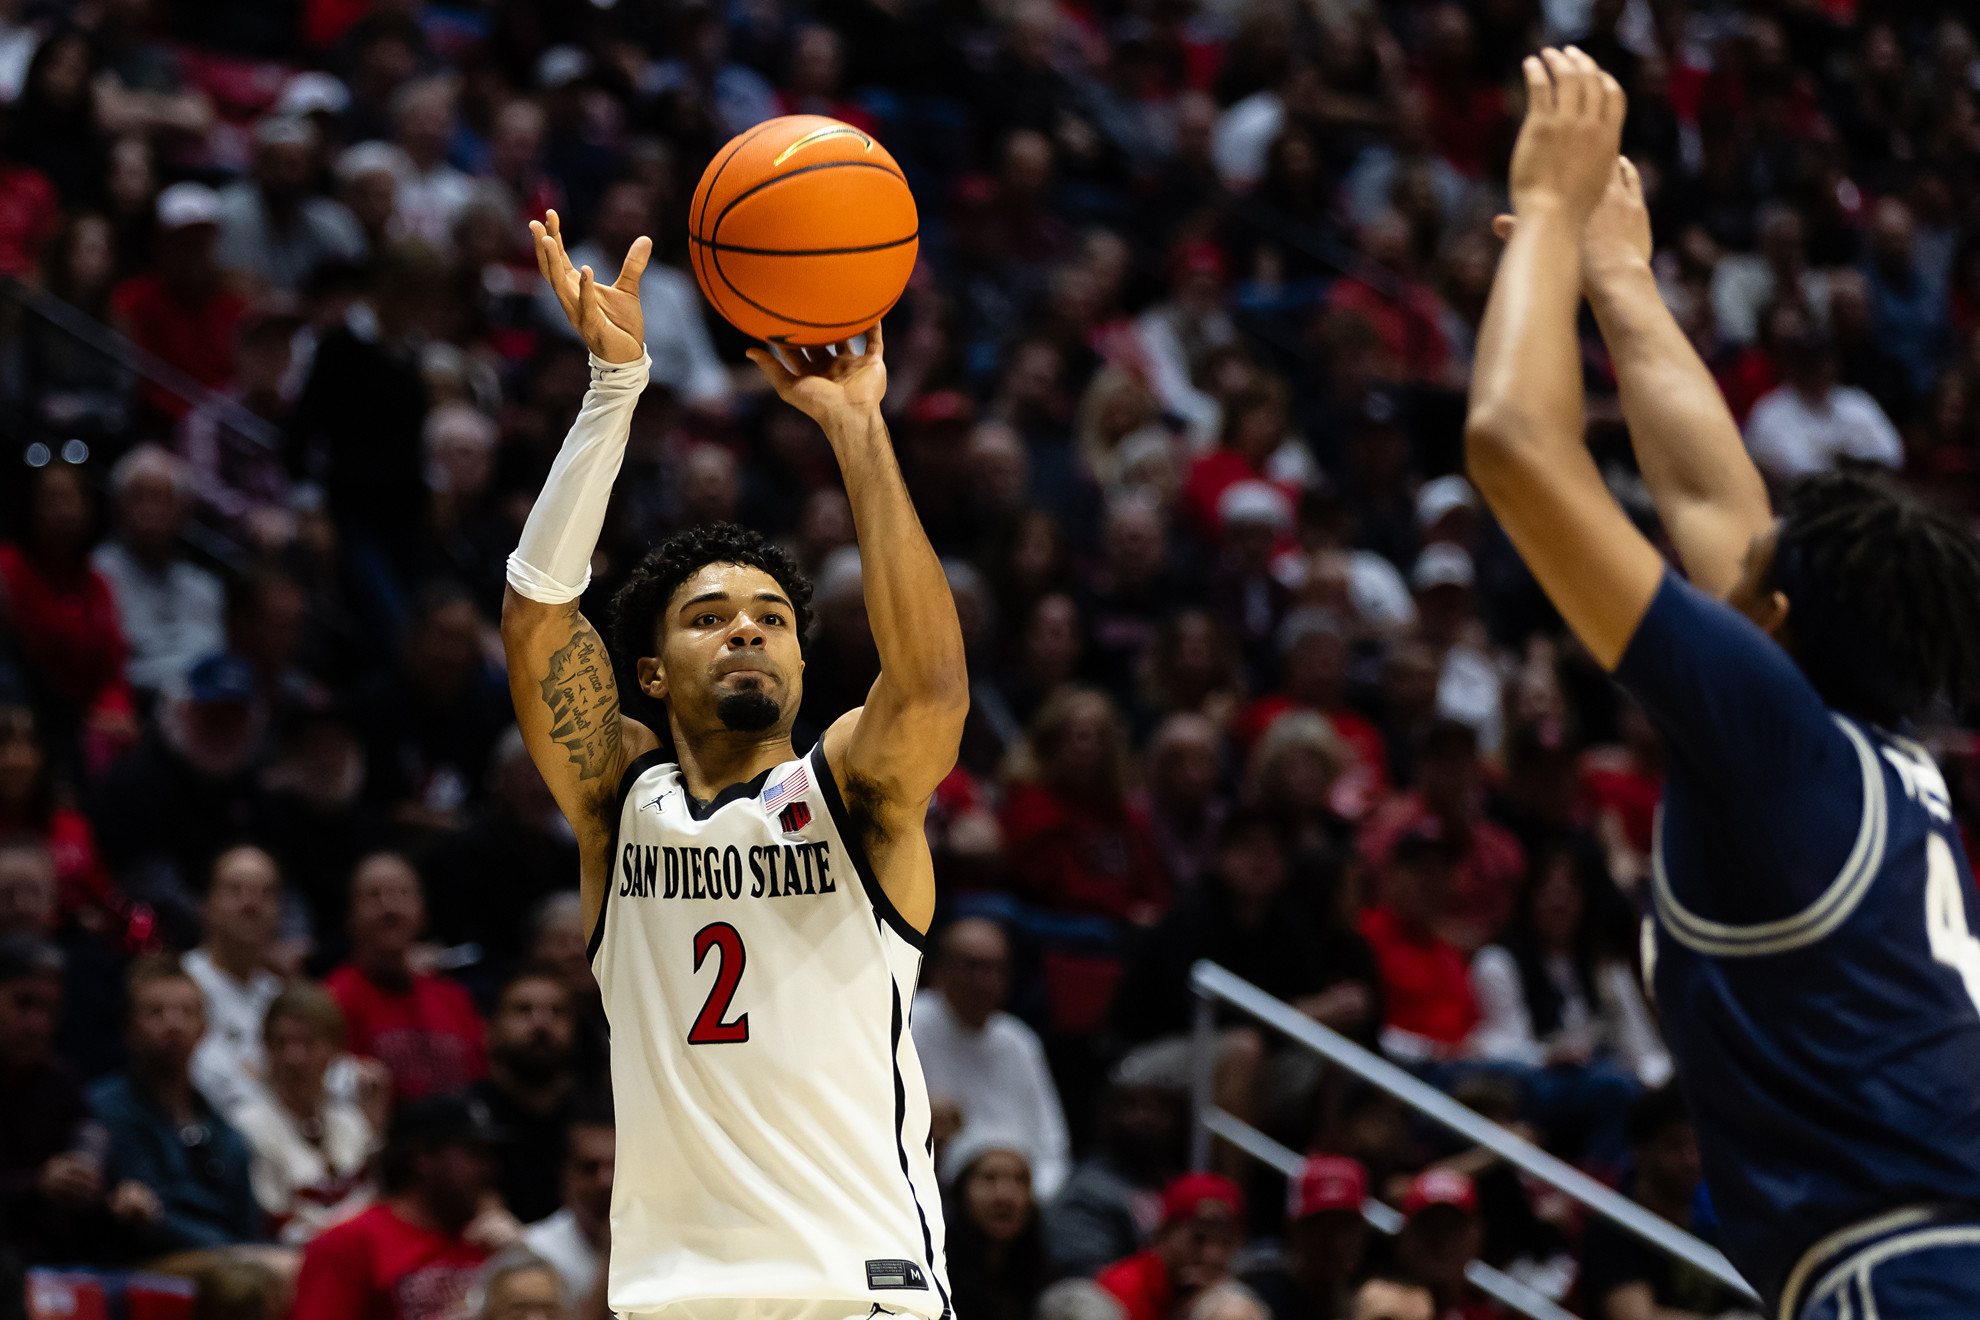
[1772,469,1980,722]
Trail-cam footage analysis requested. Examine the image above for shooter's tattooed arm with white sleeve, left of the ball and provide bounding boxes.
[501,212,655,866]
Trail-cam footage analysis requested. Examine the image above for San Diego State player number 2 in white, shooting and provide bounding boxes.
[503,214,968,1320]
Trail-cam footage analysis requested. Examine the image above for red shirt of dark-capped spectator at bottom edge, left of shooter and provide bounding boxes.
[289,1205,489,1320]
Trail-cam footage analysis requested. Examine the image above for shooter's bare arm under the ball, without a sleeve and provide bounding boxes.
[750,325,970,928]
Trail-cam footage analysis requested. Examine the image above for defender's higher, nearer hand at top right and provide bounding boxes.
[1509,46,1626,228]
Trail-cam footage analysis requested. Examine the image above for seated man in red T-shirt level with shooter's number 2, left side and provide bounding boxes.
[325,853,487,1110]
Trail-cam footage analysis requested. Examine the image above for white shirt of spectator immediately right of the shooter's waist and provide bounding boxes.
[911,990,1071,1201]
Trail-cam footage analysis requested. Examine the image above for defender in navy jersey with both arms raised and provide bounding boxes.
[1465,49,1980,1320]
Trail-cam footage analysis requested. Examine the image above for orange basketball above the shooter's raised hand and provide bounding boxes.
[687,115,921,344]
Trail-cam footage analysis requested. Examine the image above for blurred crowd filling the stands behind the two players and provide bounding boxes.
[0,0,1980,1320]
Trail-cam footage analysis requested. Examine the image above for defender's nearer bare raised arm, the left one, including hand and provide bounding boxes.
[1465,47,1663,669]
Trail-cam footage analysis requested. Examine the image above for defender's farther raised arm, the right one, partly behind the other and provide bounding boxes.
[1582,156,1774,600]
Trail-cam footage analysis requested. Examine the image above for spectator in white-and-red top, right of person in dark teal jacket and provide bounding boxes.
[236,982,382,1245]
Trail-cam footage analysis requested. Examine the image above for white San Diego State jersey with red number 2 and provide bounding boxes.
[592,746,948,1320]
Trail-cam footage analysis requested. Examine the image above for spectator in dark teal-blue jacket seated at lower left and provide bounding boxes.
[89,954,263,1257]
